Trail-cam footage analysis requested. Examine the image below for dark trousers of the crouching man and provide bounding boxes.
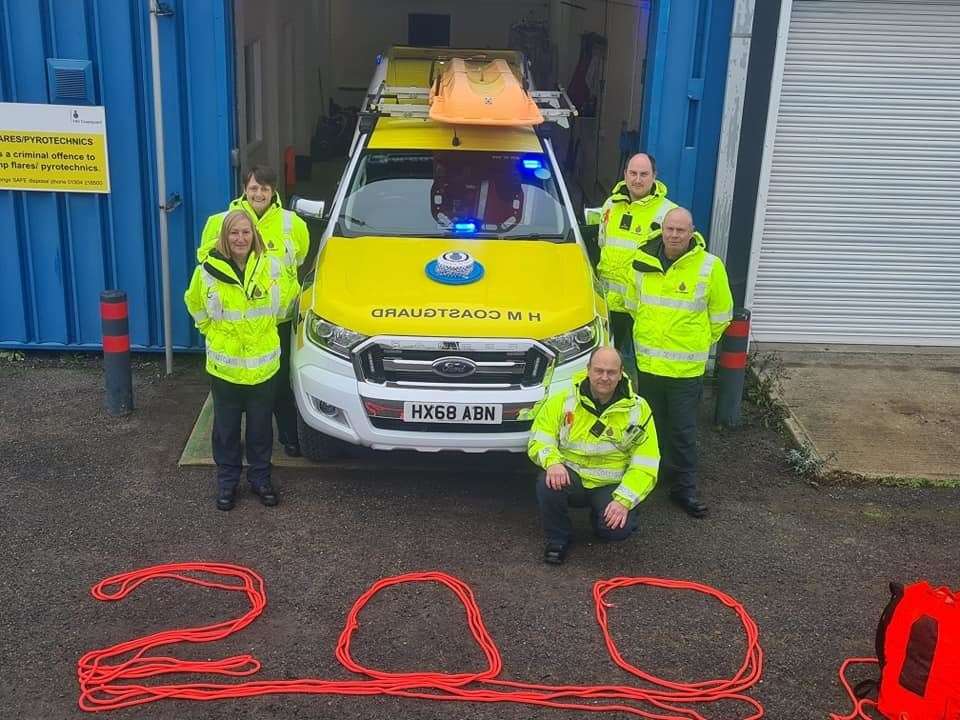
[537,468,637,545]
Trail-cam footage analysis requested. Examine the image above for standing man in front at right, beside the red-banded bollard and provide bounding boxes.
[627,207,733,518]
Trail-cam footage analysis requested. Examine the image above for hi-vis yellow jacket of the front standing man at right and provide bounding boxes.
[627,233,733,378]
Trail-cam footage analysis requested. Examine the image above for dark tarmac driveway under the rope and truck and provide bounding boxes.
[0,356,960,720]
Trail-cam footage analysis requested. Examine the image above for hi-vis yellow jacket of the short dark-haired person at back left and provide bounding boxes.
[197,194,310,320]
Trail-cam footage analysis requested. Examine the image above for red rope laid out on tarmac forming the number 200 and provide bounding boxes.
[77,563,763,720]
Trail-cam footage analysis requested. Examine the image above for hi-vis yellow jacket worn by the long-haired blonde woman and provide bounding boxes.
[183,250,297,385]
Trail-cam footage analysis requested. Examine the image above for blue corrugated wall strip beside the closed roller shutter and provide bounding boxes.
[641,0,734,232]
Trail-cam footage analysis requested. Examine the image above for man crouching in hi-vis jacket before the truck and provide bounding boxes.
[527,347,660,565]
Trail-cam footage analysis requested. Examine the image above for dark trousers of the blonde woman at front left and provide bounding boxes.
[210,376,274,488]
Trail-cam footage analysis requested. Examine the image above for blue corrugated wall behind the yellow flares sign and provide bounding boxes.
[0,0,234,349]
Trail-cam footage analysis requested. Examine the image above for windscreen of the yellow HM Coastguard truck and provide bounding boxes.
[338,150,573,242]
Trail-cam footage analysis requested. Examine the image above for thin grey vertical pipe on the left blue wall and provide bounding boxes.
[150,0,179,375]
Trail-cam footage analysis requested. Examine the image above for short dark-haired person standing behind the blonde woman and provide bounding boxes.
[197,165,310,457]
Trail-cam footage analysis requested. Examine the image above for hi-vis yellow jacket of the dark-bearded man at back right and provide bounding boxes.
[586,180,677,312]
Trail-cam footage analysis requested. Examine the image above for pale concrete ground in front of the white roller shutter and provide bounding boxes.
[754,343,960,482]
